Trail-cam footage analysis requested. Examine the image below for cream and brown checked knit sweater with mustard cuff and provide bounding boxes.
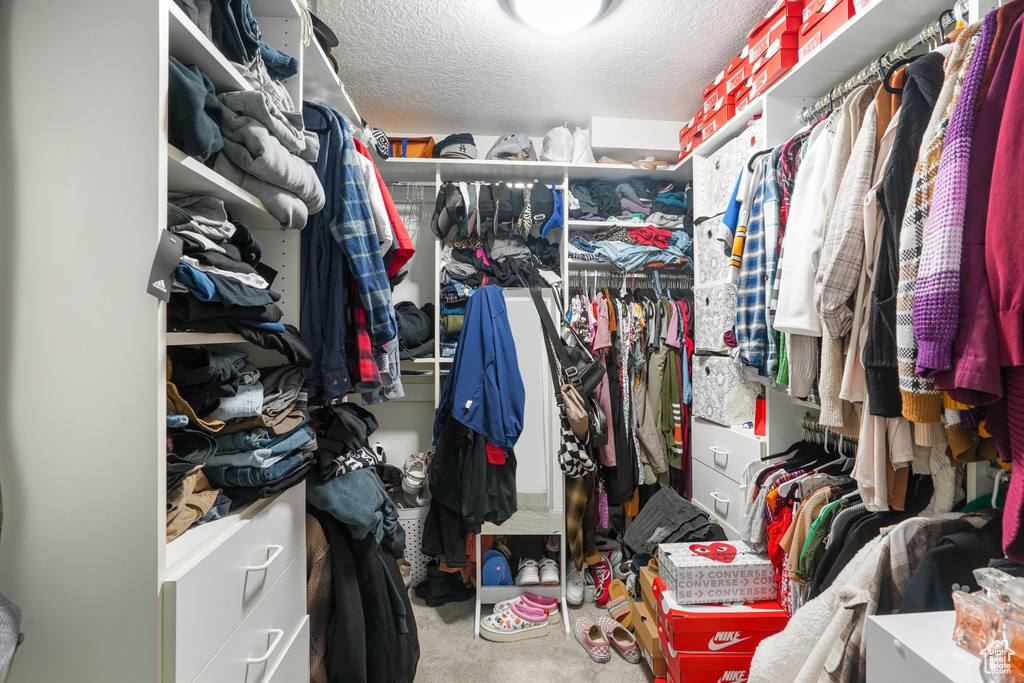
[896,24,981,424]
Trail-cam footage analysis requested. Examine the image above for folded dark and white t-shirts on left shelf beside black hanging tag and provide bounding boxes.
[167,193,311,367]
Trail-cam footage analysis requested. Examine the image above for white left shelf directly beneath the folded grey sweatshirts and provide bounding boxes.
[167,144,281,229]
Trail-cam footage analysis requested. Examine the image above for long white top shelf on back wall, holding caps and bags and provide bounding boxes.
[379,157,693,183]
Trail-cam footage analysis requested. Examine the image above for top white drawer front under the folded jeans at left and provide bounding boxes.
[164,485,306,682]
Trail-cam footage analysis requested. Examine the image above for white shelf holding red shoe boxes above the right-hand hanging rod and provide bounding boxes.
[691,0,952,158]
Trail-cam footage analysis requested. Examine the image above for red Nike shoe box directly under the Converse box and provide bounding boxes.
[654,579,790,655]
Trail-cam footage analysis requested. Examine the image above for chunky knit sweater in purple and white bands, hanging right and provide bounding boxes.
[912,12,997,376]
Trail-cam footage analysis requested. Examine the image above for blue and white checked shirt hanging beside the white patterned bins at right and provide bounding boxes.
[735,155,771,375]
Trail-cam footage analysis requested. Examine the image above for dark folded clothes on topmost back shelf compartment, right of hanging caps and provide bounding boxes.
[569,178,693,231]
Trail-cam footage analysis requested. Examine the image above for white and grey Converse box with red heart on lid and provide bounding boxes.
[659,541,778,611]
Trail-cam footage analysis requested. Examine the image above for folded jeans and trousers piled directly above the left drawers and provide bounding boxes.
[167,346,316,540]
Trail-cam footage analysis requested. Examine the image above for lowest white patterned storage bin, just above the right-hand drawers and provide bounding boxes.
[693,355,761,426]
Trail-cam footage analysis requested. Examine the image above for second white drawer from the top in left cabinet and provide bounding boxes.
[195,555,309,683]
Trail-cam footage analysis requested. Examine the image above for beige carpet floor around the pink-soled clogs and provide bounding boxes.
[410,595,654,683]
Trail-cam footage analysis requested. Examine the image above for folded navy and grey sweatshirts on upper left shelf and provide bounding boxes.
[168,56,325,229]
